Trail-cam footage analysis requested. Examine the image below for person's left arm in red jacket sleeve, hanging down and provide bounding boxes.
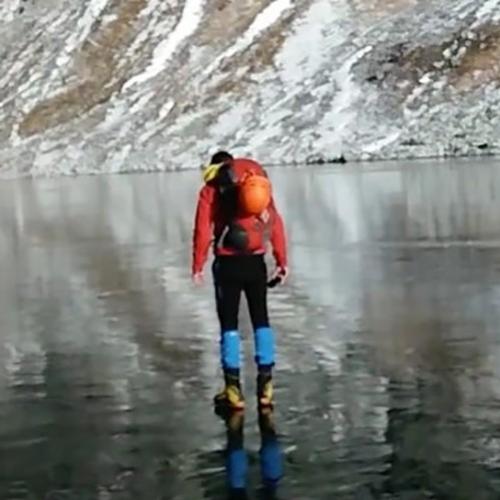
[191,185,214,276]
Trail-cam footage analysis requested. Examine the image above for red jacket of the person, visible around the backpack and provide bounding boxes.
[192,158,287,274]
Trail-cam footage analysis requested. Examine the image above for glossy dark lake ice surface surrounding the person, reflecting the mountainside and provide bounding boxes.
[0,161,500,500]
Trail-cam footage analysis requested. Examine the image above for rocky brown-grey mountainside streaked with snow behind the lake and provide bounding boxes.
[0,0,500,177]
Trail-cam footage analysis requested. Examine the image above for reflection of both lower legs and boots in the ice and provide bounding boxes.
[225,408,283,500]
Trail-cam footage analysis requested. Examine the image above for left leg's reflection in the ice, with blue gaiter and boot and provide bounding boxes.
[226,412,248,500]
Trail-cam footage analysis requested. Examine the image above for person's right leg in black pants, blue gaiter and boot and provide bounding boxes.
[244,254,275,406]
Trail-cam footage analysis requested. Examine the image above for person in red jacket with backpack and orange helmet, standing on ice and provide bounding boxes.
[192,151,288,409]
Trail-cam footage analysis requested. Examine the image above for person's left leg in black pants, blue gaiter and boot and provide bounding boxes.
[213,258,243,407]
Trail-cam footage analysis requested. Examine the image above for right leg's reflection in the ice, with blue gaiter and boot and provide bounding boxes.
[259,408,283,500]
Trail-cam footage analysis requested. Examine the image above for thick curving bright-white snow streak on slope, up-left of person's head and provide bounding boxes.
[123,0,205,90]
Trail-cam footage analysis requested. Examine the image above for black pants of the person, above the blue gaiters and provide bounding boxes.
[212,255,269,332]
